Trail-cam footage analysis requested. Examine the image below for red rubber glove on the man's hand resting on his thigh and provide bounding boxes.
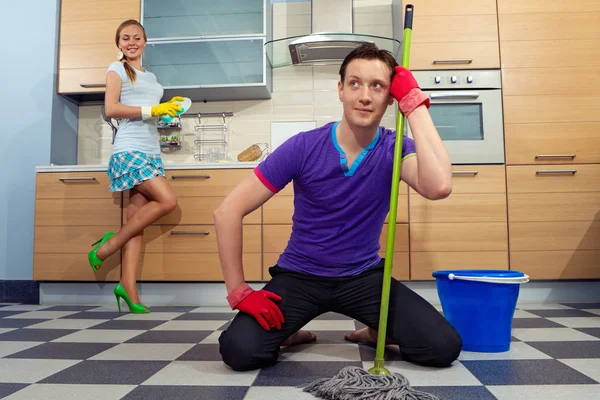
[227,283,284,331]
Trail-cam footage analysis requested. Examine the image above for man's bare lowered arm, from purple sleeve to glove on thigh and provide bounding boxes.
[213,173,274,293]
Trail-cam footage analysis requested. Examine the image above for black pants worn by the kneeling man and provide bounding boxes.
[219,260,462,371]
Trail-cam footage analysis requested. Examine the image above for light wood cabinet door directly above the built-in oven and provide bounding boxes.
[410,0,500,70]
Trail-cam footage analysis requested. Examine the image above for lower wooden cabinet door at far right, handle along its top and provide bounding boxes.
[507,164,600,279]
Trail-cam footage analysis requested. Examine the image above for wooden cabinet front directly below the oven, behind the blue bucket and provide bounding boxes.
[409,165,509,280]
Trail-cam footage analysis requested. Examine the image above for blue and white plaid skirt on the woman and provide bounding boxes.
[106,151,165,192]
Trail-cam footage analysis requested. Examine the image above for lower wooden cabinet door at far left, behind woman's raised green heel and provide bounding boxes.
[33,172,122,281]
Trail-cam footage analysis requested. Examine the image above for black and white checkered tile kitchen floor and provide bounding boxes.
[0,303,600,400]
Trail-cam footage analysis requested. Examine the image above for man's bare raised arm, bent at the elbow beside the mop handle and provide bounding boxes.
[398,105,452,200]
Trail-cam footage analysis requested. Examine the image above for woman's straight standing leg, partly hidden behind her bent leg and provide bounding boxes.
[121,188,149,304]
